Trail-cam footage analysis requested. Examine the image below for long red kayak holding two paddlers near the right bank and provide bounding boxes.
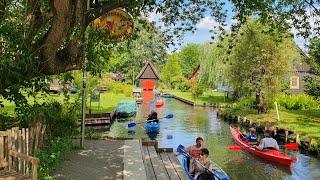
[230,126,297,167]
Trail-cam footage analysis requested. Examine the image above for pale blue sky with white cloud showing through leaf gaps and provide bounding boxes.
[148,2,314,52]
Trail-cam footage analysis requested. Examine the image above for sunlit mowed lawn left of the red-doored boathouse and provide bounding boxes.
[0,92,133,116]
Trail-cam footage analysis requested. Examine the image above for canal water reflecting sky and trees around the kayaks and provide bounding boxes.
[109,98,320,180]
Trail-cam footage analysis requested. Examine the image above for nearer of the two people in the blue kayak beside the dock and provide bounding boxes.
[190,148,213,179]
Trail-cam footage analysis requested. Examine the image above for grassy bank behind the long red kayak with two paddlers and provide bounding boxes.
[223,107,320,138]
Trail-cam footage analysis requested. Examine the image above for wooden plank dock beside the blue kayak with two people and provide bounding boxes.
[123,140,188,180]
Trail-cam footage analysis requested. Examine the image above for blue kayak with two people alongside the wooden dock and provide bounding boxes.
[181,155,229,180]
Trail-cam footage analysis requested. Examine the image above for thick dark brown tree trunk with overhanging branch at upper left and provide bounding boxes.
[34,0,130,75]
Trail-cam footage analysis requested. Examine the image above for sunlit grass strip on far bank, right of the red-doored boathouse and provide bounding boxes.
[165,90,231,105]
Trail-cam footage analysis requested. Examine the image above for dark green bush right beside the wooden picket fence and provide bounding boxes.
[35,137,73,179]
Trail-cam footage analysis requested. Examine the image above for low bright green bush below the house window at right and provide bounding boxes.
[276,94,320,110]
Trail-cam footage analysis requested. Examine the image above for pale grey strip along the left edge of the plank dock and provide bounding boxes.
[123,140,147,180]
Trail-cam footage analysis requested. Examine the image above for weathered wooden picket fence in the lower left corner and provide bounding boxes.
[0,128,39,180]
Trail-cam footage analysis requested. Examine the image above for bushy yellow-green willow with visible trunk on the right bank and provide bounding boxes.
[228,21,300,113]
